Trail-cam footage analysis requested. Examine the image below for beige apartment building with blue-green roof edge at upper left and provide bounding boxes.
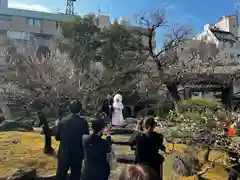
[0,0,72,48]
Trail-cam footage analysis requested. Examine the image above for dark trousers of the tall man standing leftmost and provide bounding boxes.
[56,157,83,180]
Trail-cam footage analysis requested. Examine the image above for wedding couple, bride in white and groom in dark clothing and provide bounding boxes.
[102,94,125,127]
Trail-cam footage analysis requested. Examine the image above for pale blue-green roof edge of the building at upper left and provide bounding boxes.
[0,7,73,21]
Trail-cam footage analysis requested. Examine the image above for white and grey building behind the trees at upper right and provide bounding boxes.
[178,11,240,101]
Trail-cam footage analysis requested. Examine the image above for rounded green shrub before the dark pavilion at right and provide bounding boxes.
[168,98,227,129]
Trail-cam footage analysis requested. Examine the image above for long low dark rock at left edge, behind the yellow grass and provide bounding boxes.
[0,120,33,131]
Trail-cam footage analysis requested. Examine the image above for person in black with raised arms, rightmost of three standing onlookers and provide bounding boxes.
[129,117,166,179]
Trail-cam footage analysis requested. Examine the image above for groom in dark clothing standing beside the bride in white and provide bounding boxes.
[101,95,113,124]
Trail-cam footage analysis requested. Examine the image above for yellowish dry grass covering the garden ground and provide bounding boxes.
[0,132,227,180]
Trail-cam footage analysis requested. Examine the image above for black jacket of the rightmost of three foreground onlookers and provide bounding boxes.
[129,132,166,171]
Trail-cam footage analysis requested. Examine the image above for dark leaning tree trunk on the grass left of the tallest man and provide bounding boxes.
[38,112,54,154]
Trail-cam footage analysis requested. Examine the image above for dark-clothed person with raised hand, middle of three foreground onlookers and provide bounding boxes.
[82,119,111,180]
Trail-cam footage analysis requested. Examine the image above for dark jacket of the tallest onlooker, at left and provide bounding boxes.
[55,114,89,159]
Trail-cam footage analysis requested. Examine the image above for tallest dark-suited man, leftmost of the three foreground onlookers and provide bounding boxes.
[55,100,89,180]
